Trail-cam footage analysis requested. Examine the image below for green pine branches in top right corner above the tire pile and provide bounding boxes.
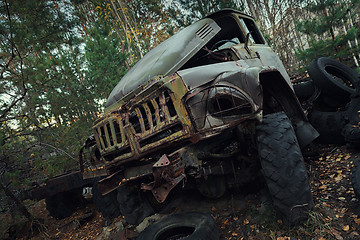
[297,0,360,65]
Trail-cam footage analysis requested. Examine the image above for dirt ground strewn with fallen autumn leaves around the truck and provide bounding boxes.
[3,145,360,240]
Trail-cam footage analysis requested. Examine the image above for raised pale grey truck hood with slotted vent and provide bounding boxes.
[105,18,220,107]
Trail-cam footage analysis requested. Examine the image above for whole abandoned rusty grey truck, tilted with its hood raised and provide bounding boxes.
[80,9,318,224]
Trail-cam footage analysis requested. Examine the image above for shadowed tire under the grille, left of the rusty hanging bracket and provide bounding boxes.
[117,185,155,225]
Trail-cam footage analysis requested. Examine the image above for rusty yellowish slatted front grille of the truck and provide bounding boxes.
[93,91,188,161]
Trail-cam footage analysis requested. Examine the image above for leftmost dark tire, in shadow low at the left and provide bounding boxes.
[45,188,85,219]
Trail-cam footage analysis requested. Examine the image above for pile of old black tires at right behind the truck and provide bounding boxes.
[294,57,360,144]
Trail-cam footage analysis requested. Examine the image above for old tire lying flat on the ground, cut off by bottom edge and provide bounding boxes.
[137,212,219,240]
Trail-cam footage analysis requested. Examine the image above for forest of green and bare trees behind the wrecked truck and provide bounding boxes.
[0,0,360,231]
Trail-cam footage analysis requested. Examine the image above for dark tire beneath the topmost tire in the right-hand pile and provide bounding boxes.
[308,110,345,144]
